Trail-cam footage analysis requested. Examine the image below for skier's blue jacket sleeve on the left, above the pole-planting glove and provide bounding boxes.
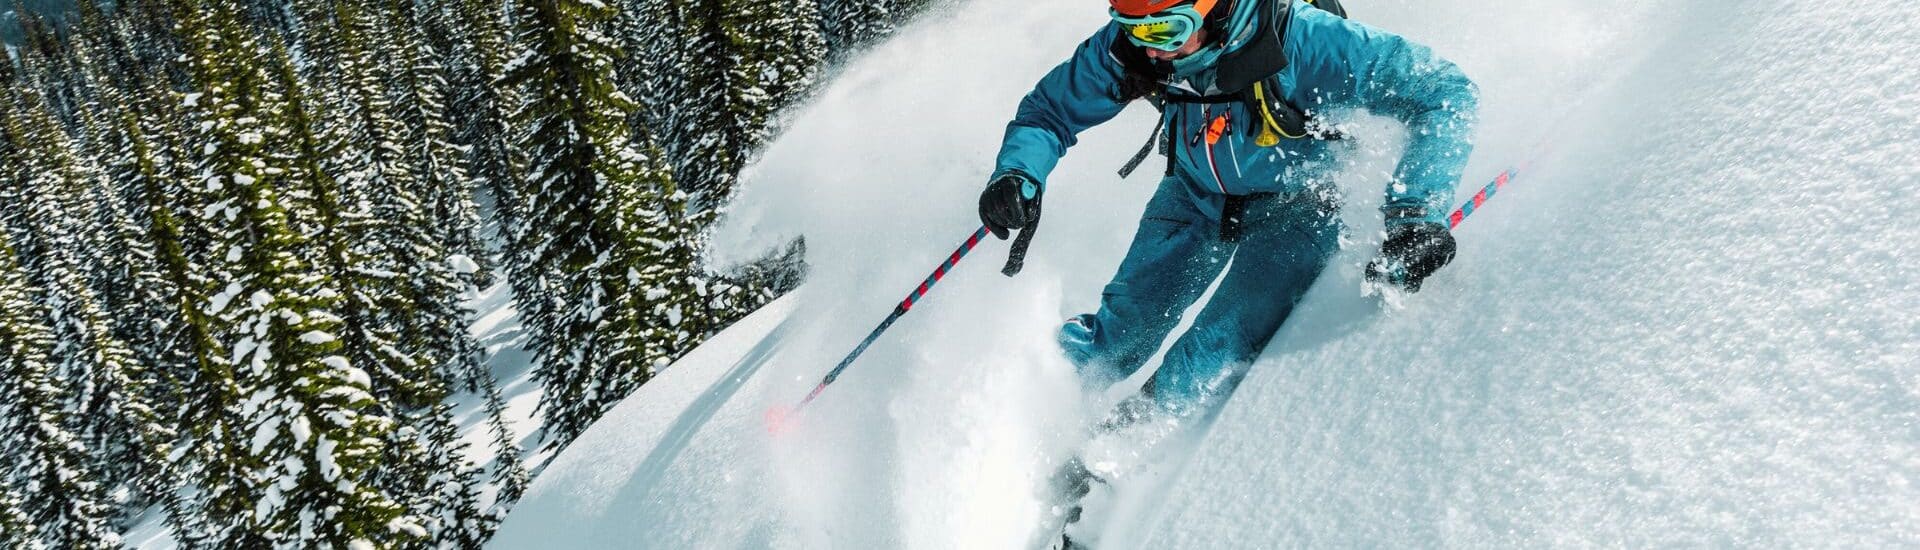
[993,25,1127,185]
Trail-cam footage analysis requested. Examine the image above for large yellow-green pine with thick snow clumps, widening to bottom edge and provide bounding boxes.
[174,2,424,548]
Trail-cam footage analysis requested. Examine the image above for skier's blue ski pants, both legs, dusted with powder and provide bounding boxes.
[1060,173,1340,415]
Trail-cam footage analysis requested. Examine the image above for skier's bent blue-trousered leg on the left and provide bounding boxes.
[1060,175,1229,388]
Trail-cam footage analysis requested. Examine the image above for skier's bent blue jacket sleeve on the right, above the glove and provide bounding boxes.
[1286,2,1478,227]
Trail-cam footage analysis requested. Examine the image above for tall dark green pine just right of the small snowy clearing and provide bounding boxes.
[507,0,691,446]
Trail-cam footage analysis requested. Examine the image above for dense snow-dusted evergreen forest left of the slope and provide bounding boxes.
[0,0,927,548]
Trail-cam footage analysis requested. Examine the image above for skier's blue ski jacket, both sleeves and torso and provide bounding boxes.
[995,0,1478,225]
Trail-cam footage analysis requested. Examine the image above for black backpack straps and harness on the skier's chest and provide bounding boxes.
[1110,0,1346,177]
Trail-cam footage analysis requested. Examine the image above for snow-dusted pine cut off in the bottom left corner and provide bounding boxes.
[0,227,121,548]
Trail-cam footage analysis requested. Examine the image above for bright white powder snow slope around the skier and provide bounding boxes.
[493,0,1920,548]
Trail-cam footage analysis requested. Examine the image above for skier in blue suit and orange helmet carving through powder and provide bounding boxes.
[979,0,1478,417]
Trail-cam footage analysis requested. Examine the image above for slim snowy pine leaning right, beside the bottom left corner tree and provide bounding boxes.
[4,55,173,534]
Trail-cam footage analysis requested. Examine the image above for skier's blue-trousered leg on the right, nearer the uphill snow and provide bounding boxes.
[1148,196,1340,413]
